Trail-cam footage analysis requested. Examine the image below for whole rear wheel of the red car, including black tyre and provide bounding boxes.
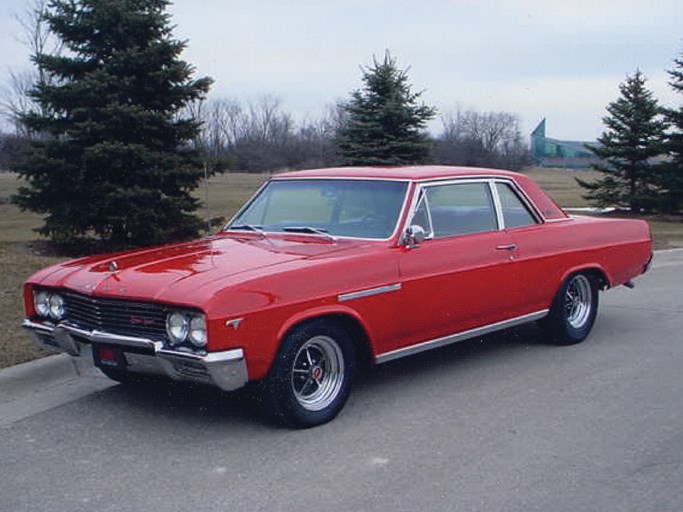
[541,273,598,345]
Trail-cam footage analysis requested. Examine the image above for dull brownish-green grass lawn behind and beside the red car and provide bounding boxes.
[0,169,683,368]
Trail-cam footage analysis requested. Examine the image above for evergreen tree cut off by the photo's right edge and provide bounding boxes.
[660,50,683,213]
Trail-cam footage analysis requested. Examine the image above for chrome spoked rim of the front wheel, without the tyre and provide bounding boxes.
[291,335,344,411]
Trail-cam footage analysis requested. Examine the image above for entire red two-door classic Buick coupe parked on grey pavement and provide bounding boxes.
[23,166,652,427]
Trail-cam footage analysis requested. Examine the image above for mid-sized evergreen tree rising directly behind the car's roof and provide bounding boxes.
[336,51,436,165]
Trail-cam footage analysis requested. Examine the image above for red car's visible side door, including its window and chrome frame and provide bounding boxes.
[392,180,519,352]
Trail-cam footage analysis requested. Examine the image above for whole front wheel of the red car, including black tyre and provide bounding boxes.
[262,320,356,428]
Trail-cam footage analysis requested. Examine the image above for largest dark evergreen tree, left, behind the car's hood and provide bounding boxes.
[13,0,211,249]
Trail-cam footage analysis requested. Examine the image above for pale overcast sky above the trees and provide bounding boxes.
[0,0,683,140]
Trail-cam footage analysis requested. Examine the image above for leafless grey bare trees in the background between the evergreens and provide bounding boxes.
[0,95,530,173]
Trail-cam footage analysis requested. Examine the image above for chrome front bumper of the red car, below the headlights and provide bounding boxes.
[22,320,248,391]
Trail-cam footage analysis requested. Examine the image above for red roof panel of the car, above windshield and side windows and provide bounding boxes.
[273,165,520,181]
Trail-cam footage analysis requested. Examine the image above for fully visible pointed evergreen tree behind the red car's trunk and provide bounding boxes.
[576,71,666,212]
